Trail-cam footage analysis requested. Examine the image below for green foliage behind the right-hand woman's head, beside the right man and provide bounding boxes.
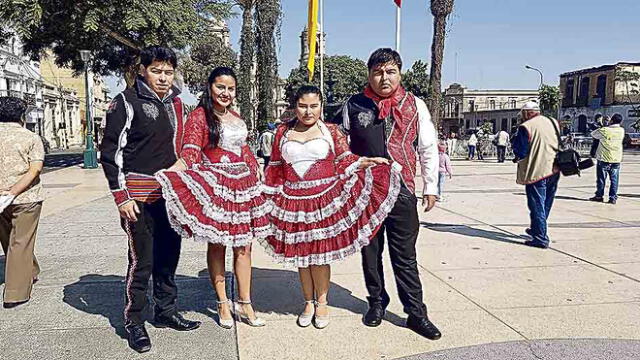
[285,55,368,104]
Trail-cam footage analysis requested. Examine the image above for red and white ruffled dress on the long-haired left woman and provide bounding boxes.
[156,108,271,247]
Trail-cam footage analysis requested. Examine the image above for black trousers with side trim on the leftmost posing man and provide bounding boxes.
[121,199,181,325]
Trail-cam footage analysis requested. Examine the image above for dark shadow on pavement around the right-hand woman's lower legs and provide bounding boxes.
[240,267,405,327]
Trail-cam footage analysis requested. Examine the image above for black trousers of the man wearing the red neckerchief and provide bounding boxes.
[362,185,427,317]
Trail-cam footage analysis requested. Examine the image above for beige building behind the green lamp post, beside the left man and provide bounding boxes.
[40,56,111,147]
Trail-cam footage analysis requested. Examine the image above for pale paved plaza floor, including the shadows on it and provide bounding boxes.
[0,154,640,360]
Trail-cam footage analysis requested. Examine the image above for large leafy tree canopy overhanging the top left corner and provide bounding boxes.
[0,0,231,85]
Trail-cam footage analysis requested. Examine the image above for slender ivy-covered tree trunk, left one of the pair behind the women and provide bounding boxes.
[238,0,256,124]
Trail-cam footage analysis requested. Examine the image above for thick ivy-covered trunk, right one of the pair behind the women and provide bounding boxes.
[255,0,280,129]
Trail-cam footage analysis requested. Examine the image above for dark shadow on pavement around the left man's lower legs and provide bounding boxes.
[63,274,216,339]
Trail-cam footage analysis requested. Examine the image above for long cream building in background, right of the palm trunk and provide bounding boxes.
[440,84,539,134]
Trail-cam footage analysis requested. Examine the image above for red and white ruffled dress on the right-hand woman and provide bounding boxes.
[261,122,401,267]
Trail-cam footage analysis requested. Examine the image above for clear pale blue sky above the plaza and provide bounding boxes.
[108,0,640,102]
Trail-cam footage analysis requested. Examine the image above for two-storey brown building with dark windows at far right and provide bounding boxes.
[559,62,640,134]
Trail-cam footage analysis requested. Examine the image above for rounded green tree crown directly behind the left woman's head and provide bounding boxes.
[180,34,238,94]
